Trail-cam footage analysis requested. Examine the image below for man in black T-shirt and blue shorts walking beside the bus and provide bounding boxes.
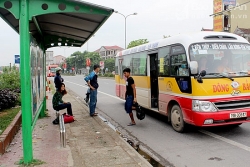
[123,68,137,126]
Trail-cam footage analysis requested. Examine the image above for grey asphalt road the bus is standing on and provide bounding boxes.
[61,76,250,167]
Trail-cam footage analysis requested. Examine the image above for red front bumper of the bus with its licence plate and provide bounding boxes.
[190,109,250,127]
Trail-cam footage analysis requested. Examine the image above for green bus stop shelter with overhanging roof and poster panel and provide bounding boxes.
[0,0,114,163]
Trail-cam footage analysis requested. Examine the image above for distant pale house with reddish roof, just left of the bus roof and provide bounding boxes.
[95,45,123,59]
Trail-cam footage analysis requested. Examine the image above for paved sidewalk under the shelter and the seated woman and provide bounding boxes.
[0,88,151,167]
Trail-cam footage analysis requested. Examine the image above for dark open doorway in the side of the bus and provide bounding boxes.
[148,53,159,110]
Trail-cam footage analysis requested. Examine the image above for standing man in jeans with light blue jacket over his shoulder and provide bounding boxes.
[84,64,100,117]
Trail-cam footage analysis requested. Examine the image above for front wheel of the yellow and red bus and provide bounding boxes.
[171,105,185,132]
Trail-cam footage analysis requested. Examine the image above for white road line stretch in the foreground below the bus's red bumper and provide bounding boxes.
[199,130,250,152]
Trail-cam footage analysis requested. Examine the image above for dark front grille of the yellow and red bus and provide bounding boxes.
[214,100,250,110]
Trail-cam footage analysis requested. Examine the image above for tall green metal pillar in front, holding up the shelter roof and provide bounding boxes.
[19,0,33,164]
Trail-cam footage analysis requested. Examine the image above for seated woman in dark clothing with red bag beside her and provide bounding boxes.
[52,83,73,116]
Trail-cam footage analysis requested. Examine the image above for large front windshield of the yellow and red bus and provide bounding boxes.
[189,42,250,77]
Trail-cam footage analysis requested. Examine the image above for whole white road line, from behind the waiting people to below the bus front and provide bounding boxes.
[65,81,250,152]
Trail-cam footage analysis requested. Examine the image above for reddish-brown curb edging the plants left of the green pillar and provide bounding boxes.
[0,111,22,155]
